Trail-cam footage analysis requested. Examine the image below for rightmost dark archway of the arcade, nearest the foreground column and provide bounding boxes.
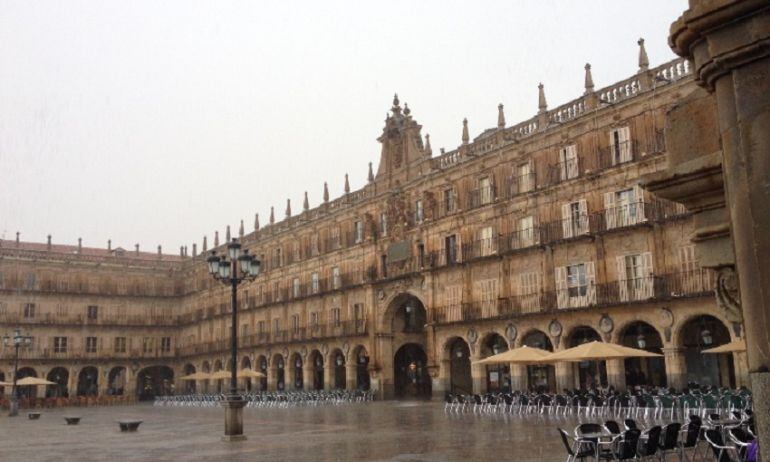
[679,315,735,387]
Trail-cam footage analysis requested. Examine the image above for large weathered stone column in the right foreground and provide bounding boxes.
[669,0,770,458]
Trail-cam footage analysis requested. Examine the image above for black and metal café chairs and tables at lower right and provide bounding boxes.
[444,388,757,462]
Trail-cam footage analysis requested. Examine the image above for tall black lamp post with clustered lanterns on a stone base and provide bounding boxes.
[206,239,260,441]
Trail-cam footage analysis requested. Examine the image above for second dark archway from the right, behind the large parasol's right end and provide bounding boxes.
[620,321,667,387]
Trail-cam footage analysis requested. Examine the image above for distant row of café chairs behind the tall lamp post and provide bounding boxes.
[153,390,374,408]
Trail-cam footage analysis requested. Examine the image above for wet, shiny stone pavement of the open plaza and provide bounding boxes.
[0,401,575,462]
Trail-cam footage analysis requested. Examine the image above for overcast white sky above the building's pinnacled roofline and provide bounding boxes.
[0,0,687,253]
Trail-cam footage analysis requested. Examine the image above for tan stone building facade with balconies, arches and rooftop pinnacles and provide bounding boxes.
[0,46,746,398]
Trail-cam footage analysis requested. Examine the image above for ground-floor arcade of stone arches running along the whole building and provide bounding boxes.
[0,293,746,400]
